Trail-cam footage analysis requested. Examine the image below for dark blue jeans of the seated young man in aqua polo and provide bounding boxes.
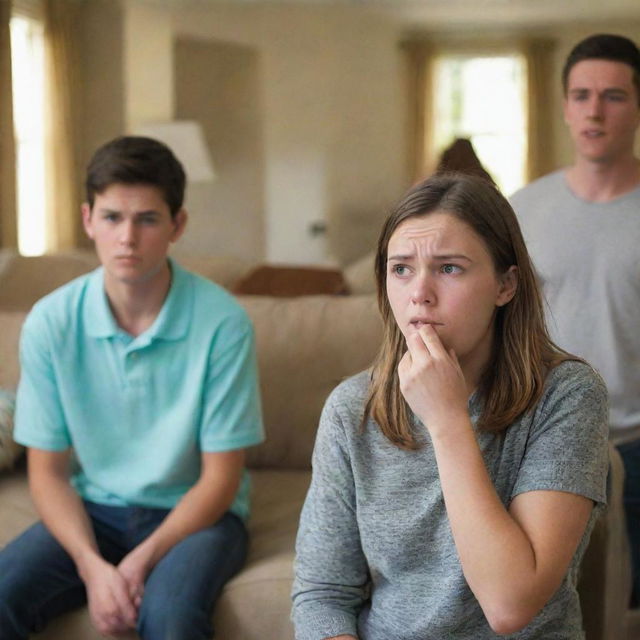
[0,502,248,640]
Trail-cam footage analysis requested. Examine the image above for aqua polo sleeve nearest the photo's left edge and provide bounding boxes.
[14,307,71,451]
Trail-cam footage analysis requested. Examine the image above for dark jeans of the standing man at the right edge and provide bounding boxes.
[618,440,640,608]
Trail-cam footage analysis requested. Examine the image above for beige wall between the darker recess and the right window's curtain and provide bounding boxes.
[173,4,406,263]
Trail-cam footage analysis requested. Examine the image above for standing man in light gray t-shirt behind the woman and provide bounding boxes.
[511,35,640,606]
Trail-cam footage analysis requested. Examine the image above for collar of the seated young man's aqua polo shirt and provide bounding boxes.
[84,258,193,342]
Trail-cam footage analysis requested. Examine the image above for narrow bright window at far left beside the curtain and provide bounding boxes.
[10,10,46,255]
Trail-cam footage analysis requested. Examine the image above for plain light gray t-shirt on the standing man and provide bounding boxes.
[511,171,640,443]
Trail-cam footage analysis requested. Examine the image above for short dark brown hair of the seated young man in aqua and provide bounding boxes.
[85,136,186,218]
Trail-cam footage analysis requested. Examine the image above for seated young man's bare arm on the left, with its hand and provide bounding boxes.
[28,448,137,634]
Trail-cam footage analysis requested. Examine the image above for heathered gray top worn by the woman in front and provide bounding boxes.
[293,362,608,640]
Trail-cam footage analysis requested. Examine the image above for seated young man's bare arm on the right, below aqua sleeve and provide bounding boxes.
[118,449,245,605]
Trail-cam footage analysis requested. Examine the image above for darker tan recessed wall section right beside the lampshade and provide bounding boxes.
[174,36,265,262]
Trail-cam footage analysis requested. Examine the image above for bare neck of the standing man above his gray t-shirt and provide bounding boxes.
[565,155,640,202]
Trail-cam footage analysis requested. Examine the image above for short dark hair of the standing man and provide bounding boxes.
[562,33,640,103]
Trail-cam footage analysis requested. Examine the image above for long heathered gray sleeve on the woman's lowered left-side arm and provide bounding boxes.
[292,394,369,640]
